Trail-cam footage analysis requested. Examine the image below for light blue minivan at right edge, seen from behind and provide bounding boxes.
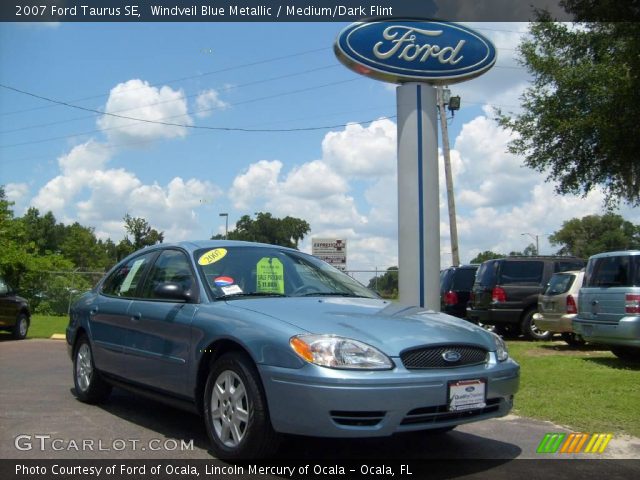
[573,250,640,360]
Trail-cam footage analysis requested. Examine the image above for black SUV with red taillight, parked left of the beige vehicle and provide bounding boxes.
[467,257,585,340]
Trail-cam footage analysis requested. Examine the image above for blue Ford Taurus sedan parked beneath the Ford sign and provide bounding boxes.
[67,241,519,459]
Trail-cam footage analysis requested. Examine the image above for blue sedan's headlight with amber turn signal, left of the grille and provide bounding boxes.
[289,335,393,370]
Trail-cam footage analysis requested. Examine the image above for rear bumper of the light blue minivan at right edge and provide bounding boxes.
[573,316,640,348]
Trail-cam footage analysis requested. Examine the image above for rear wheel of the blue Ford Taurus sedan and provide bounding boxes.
[73,335,111,403]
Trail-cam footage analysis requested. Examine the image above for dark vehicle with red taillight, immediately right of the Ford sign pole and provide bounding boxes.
[440,265,478,318]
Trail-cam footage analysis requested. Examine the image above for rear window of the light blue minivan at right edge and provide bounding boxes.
[585,255,640,287]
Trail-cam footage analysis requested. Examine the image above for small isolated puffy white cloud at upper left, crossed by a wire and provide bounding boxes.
[97,79,193,142]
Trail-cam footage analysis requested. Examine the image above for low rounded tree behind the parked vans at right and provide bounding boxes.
[549,213,640,258]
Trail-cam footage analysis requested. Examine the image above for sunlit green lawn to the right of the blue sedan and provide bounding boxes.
[508,341,640,436]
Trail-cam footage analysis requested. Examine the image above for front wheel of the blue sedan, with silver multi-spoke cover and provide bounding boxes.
[203,352,279,460]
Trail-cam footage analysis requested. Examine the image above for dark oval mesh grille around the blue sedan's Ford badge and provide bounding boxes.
[400,345,487,370]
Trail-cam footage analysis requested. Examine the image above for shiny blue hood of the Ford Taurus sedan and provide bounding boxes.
[228,297,495,356]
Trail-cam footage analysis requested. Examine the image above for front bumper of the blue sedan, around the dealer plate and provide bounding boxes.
[259,359,520,437]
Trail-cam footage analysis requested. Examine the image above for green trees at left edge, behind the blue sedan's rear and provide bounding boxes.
[0,186,163,315]
